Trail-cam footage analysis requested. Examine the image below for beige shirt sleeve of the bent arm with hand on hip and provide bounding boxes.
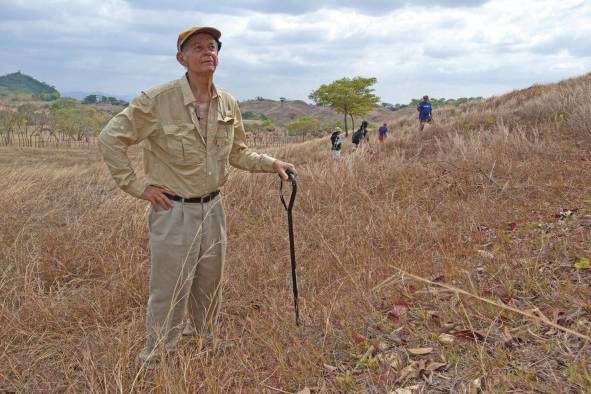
[98,92,158,198]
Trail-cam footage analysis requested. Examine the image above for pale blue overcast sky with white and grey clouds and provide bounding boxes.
[0,0,591,103]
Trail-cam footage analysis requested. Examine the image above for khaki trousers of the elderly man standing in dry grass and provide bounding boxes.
[140,195,226,362]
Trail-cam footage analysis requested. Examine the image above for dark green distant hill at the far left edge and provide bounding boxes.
[0,71,60,101]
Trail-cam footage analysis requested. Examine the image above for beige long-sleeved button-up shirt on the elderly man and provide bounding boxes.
[98,76,275,197]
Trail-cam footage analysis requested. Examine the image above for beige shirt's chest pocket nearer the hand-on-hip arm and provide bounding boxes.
[158,123,205,165]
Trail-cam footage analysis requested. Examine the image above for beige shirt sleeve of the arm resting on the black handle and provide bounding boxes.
[230,104,276,172]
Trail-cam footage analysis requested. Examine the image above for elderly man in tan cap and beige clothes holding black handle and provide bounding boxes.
[99,26,295,363]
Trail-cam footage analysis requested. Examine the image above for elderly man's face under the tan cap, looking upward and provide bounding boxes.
[176,33,218,74]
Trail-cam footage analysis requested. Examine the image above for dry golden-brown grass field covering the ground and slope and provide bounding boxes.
[0,75,591,393]
